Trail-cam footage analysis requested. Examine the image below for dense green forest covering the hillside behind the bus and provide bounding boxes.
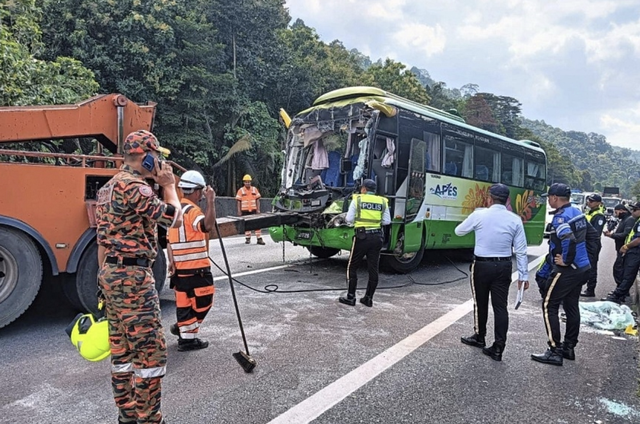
[0,0,640,195]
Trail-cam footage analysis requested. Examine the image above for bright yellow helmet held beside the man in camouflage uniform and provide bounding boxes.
[65,314,111,362]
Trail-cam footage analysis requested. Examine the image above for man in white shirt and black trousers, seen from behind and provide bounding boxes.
[455,184,529,361]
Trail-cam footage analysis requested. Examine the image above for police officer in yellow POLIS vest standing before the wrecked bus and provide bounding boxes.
[338,179,391,307]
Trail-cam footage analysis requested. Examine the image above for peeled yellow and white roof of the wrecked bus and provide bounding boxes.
[300,86,544,153]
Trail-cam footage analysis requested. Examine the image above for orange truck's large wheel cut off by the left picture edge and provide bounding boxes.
[0,228,42,328]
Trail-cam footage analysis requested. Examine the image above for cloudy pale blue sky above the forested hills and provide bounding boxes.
[286,0,640,150]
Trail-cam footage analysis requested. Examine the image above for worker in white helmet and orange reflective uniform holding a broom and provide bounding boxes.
[167,171,216,352]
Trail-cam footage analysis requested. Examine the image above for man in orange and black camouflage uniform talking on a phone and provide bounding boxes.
[96,131,182,424]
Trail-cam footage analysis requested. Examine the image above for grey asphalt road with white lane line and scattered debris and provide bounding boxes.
[0,237,640,424]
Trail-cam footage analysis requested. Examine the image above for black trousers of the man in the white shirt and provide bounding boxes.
[471,261,511,347]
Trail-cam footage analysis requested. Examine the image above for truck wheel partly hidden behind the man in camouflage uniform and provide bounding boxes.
[76,243,167,313]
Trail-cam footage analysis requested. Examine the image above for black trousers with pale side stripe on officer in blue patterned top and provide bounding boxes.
[542,270,588,348]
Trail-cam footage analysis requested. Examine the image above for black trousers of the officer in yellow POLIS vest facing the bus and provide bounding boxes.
[347,232,382,297]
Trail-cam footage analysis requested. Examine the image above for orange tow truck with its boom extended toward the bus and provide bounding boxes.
[0,94,297,328]
